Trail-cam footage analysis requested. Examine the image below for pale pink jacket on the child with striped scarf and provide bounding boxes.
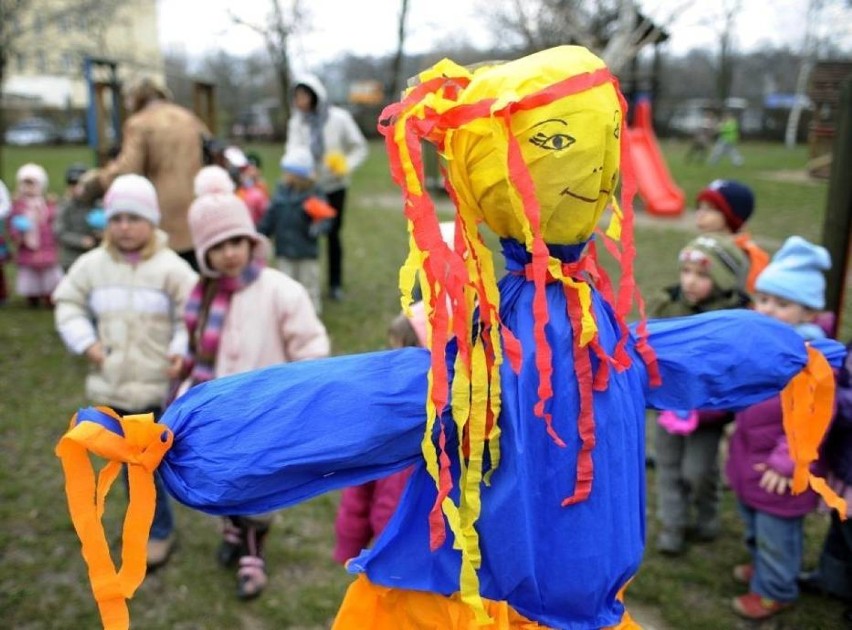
[216,268,330,378]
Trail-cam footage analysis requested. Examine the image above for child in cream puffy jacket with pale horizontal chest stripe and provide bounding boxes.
[53,175,197,570]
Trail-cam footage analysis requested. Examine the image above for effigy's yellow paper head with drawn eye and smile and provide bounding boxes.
[444,46,622,244]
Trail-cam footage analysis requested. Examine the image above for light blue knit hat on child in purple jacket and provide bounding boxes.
[754,236,831,310]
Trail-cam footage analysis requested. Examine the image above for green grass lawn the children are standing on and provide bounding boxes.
[0,142,852,630]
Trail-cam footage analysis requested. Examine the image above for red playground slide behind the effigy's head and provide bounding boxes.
[627,99,686,217]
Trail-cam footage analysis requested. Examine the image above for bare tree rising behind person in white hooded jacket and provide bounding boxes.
[230,0,308,139]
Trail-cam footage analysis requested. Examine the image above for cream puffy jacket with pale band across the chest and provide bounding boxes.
[53,230,197,411]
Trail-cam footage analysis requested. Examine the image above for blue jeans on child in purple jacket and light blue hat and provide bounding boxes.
[738,503,805,602]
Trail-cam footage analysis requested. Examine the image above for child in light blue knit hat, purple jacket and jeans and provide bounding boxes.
[726,236,831,620]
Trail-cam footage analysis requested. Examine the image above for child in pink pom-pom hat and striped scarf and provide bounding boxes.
[184,191,329,599]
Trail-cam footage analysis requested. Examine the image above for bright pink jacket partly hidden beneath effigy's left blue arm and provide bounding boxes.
[332,466,413,564]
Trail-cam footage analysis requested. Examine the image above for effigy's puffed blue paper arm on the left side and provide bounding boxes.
[159,348,429,514]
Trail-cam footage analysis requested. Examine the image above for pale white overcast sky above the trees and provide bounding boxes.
[158,0,852,71]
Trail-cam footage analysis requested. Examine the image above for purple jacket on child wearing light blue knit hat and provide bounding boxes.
[725,396,819,518]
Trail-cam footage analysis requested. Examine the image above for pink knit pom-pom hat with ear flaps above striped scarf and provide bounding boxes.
[189,193,269,278]
